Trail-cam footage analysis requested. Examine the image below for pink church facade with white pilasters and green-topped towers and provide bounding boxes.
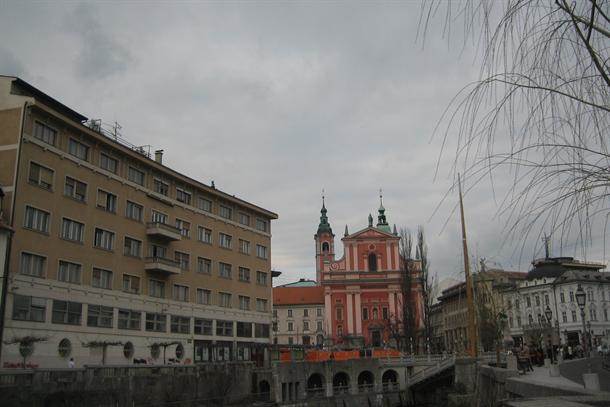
[314,199,423,347]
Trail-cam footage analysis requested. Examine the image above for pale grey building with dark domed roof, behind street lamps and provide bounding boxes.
[504,257,610,347]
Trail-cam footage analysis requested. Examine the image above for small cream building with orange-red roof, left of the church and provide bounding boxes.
[272,286,326,346]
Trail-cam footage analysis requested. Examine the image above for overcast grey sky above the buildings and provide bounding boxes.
[0,0,605,283]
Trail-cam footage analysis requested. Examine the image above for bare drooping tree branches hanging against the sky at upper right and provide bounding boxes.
[420,0,610,255]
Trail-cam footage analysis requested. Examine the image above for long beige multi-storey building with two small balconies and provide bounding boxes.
[0,76,277,367]
